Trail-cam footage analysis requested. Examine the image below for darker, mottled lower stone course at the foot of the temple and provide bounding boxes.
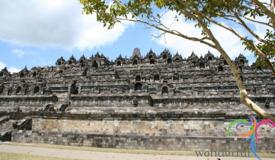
[12,131,258,152]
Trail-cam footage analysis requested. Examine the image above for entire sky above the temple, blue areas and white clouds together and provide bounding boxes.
[0,0,268,72]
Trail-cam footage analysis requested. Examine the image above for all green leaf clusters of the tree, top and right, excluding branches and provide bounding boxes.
[80,0,275,68]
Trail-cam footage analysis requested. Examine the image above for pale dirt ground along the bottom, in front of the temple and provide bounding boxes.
[0,143,275,160]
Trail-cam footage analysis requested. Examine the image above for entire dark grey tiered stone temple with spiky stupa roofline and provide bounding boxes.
[0,48,275,152]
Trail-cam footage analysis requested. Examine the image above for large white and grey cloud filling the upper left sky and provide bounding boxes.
[0,0,128,49]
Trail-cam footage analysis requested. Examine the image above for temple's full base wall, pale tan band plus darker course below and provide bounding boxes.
[12,117,275,152]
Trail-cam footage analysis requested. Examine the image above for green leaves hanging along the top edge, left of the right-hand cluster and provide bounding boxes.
[80,0,251,26]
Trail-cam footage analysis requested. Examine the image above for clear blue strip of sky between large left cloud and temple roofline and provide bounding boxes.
[0,24,165,69]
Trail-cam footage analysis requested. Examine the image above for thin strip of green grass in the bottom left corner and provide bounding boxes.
[0,152,77,160]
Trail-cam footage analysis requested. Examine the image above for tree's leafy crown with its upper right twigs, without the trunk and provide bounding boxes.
[80,0,275,67]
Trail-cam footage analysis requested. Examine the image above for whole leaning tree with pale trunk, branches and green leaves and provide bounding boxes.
[80,0,275,120]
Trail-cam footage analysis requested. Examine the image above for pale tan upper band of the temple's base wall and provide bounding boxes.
[32,118,230,137]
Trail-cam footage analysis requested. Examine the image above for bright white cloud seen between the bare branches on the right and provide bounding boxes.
[154,12,268,58]
